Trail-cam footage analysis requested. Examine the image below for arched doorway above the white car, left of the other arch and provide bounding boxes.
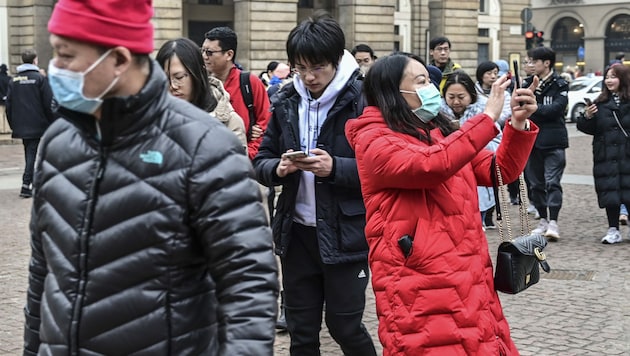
[551,17,584,72]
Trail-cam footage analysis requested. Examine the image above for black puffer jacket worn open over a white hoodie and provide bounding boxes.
[254,70,368,264]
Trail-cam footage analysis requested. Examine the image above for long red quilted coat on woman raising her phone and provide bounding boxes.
[346,107,538,356]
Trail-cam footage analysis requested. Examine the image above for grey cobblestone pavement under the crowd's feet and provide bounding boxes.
[0,124,630,356]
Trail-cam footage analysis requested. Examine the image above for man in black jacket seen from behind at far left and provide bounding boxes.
[6,49,54,198]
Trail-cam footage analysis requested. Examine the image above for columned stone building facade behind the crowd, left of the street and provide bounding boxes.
[0,0,540,73]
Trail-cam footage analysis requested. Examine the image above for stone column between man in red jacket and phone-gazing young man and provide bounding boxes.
[234,0,297,74]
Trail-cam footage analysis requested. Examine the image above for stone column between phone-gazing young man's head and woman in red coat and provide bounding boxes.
[337,0,396,56]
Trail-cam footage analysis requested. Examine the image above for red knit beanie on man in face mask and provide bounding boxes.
[48,0,153,54]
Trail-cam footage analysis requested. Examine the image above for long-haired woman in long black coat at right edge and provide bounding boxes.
[577,64,630,244]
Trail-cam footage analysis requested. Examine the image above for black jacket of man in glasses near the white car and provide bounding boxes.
[524,73,569,150]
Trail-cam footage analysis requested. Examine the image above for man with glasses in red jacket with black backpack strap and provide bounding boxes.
[201,27,270,159]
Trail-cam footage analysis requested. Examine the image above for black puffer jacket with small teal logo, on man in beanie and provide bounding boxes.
[25,62,278,356]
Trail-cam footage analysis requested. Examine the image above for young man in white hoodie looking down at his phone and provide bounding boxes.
[254,14,376,356]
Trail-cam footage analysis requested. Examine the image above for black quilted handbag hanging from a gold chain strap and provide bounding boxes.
[492,158,550,294]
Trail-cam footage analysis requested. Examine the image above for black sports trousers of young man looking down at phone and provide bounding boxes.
[282,223,376,356]
